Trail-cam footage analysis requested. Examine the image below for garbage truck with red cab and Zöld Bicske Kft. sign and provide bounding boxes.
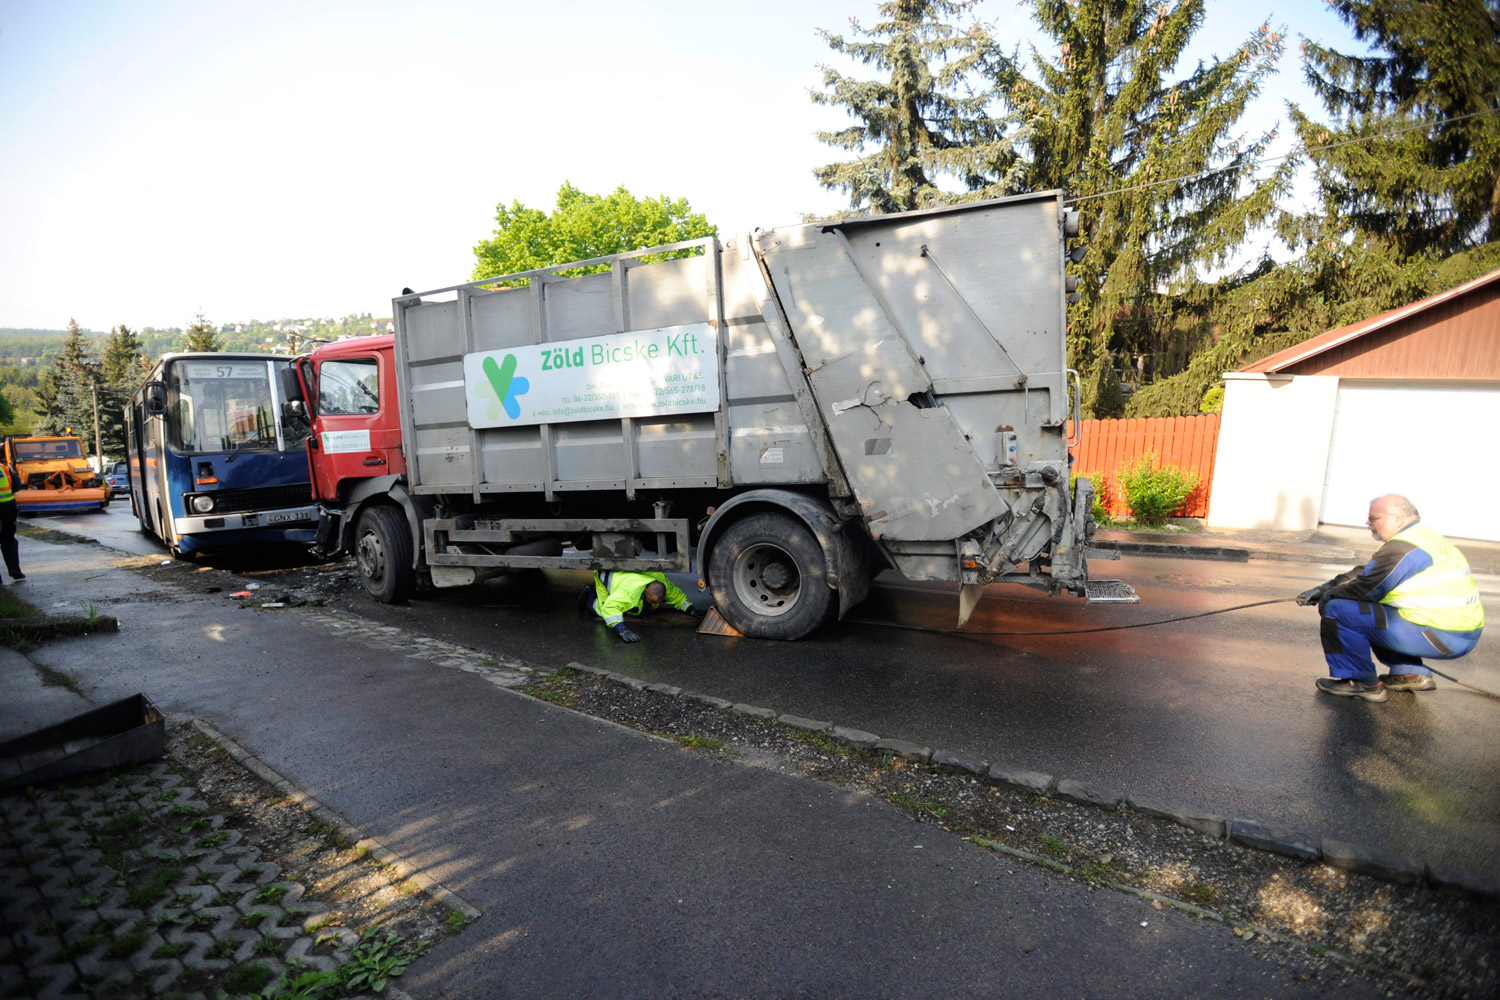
[284,192,1121,639]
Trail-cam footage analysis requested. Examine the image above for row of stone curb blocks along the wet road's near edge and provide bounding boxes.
[564,663,1500,905]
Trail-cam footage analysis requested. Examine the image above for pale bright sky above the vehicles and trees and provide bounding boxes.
[0,0,1356,331]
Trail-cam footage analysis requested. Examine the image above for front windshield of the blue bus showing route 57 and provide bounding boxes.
[167,360,306,453]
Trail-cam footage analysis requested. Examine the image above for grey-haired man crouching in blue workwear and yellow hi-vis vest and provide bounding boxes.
[1298,493,1485,702]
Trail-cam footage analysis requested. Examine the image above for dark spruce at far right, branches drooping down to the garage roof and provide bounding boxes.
[1128,0,1500,417]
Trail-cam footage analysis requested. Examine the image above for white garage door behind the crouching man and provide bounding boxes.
[1319,381,1500,541]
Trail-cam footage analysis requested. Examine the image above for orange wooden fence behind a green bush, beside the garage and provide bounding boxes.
[1068,414,1220,517]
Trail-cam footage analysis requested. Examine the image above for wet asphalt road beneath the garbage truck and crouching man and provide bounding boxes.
[26,505,1500,877]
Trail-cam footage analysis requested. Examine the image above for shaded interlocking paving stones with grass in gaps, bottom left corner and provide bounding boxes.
[0,763,357,1000]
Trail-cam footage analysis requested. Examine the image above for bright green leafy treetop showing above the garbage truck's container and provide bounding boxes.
[473,181,719,283]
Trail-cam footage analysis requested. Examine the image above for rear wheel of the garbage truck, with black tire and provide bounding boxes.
[710,511,837,640]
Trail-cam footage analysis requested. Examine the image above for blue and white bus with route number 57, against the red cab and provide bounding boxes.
[125,352,318,556]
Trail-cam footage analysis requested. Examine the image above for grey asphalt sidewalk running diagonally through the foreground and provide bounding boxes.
[0,540,1377,997]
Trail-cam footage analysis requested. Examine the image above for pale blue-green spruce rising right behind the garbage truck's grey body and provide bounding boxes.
[810,0,1022,214]
